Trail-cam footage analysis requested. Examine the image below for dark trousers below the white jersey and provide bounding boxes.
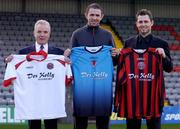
[28,119,57,129]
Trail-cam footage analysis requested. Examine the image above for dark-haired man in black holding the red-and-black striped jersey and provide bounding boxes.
[124,9,173,129]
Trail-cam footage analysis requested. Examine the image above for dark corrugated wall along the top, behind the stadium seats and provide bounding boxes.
[0,0,180,18]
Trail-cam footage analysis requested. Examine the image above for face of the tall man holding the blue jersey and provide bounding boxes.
[85,8,104,26]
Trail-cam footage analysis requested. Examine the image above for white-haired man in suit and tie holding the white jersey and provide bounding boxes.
[5,20,64,129]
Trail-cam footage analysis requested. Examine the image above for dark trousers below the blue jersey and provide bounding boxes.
[74,116,109,129]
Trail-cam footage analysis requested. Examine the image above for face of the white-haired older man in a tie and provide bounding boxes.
[34,24,50,44]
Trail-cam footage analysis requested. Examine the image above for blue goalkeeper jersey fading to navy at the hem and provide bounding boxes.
[71,46,113,116]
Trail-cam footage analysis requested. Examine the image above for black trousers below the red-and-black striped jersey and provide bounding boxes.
[126,118,161,129]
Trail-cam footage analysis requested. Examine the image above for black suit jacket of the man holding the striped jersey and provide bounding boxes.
[124,35,173,72]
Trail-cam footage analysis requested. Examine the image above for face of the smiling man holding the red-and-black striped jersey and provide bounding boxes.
[136,15,153,37]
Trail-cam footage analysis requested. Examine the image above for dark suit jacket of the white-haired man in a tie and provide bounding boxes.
[19,45,64,55]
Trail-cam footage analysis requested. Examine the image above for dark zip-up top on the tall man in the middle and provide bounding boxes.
[70,25,114,47]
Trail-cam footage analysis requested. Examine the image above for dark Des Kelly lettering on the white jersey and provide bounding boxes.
[27,72,54,80]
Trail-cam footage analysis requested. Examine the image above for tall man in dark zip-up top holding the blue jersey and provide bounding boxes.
[65,3,117,129]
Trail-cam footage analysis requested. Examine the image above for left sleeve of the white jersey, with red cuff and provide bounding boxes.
[3,62,16,87]
